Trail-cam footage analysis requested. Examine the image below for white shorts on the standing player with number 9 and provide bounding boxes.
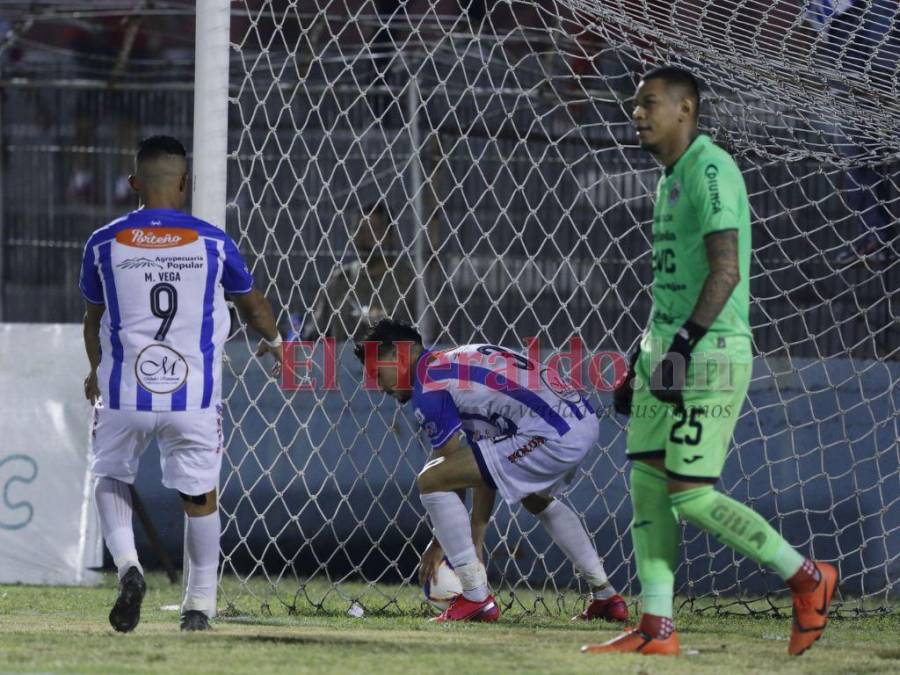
[91,405,224,496]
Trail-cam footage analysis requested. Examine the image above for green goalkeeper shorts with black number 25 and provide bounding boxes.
[627,337,753,483]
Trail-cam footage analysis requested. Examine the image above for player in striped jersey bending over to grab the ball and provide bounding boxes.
[356,319,628,622]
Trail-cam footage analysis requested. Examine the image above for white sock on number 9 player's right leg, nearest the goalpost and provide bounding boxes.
[181,510,221,618]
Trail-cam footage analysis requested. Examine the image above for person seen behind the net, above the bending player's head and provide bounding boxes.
[295,201,416,340]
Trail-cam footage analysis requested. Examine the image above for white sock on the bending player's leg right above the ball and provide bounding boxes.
[420,492,490,602]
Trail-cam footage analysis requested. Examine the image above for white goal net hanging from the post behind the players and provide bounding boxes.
[216,0,900,613]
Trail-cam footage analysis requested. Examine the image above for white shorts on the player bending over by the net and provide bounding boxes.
[475,415,600,504]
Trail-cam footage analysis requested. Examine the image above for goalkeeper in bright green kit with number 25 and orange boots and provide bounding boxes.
[583,67,838,655]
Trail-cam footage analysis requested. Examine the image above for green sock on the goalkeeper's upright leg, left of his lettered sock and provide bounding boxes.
[631,461,681,619]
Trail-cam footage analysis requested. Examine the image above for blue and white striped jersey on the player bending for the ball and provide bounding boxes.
[412,344,594,448]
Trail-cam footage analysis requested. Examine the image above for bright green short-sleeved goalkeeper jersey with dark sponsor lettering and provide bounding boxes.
[650,134,750,345]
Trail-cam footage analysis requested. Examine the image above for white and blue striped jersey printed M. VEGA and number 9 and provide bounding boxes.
[79,209,253,412]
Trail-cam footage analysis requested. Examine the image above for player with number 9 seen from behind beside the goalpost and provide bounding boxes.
[79,136,281,633]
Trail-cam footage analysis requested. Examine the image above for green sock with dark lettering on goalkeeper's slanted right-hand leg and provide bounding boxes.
[672,486,804,579]
